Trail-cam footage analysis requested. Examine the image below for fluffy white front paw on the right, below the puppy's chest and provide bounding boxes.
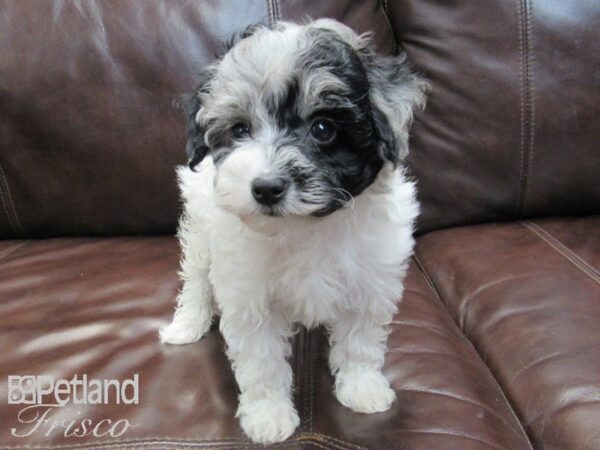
[335,368,396,414]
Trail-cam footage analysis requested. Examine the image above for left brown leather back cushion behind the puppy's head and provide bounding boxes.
[0,0,394,238]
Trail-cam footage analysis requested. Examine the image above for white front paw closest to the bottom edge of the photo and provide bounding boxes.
[236,397,300,444]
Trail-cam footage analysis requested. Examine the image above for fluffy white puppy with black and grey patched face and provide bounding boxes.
[160,19,426,444]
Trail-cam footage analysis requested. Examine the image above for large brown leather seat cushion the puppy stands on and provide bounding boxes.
[0,237,529,450]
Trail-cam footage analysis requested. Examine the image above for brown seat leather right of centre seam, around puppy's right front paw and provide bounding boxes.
[309,264,530,450]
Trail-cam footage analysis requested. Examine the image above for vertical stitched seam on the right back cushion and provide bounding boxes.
[516,0,535,217]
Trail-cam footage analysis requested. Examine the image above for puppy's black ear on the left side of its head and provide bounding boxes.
[183,70,211,170]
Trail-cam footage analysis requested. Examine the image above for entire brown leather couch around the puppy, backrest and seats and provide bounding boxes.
[0,0,600,450]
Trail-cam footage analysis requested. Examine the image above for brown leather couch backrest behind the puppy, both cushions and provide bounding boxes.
[0,0,600,237]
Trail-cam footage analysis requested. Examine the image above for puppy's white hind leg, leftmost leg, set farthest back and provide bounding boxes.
[160,214,215,345]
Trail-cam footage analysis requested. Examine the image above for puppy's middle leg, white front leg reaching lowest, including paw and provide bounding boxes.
[217,300,300,444]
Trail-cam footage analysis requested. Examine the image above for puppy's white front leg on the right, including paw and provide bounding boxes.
[329,312,396,414]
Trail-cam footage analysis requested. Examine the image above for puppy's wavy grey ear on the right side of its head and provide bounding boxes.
[362,52,429,165]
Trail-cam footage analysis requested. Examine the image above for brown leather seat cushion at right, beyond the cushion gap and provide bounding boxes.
[418,217,600,449]
